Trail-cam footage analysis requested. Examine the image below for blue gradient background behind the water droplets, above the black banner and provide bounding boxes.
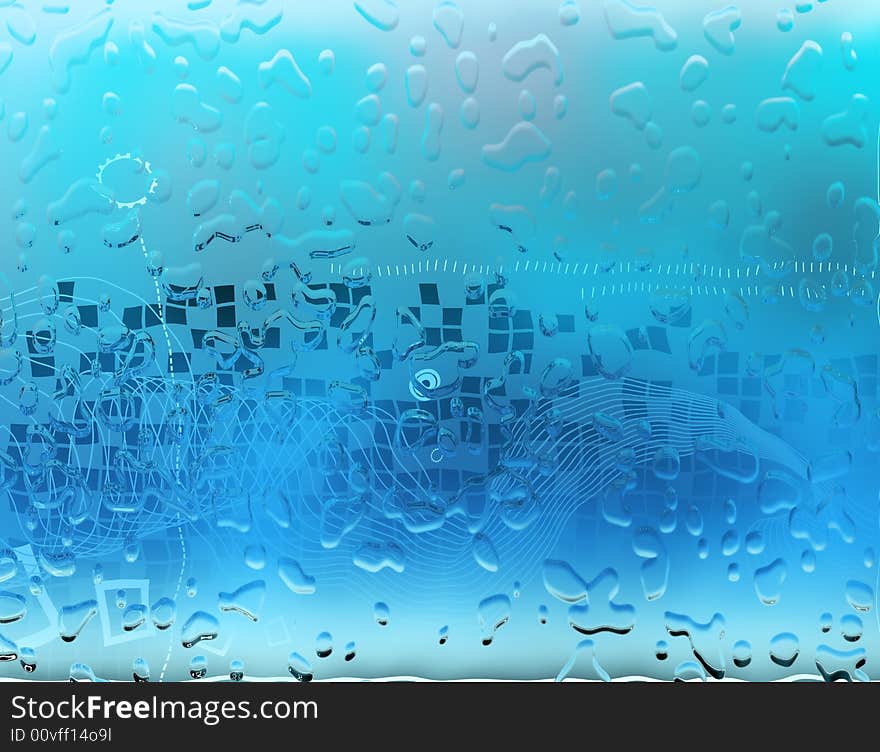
[0,0,880,680]
